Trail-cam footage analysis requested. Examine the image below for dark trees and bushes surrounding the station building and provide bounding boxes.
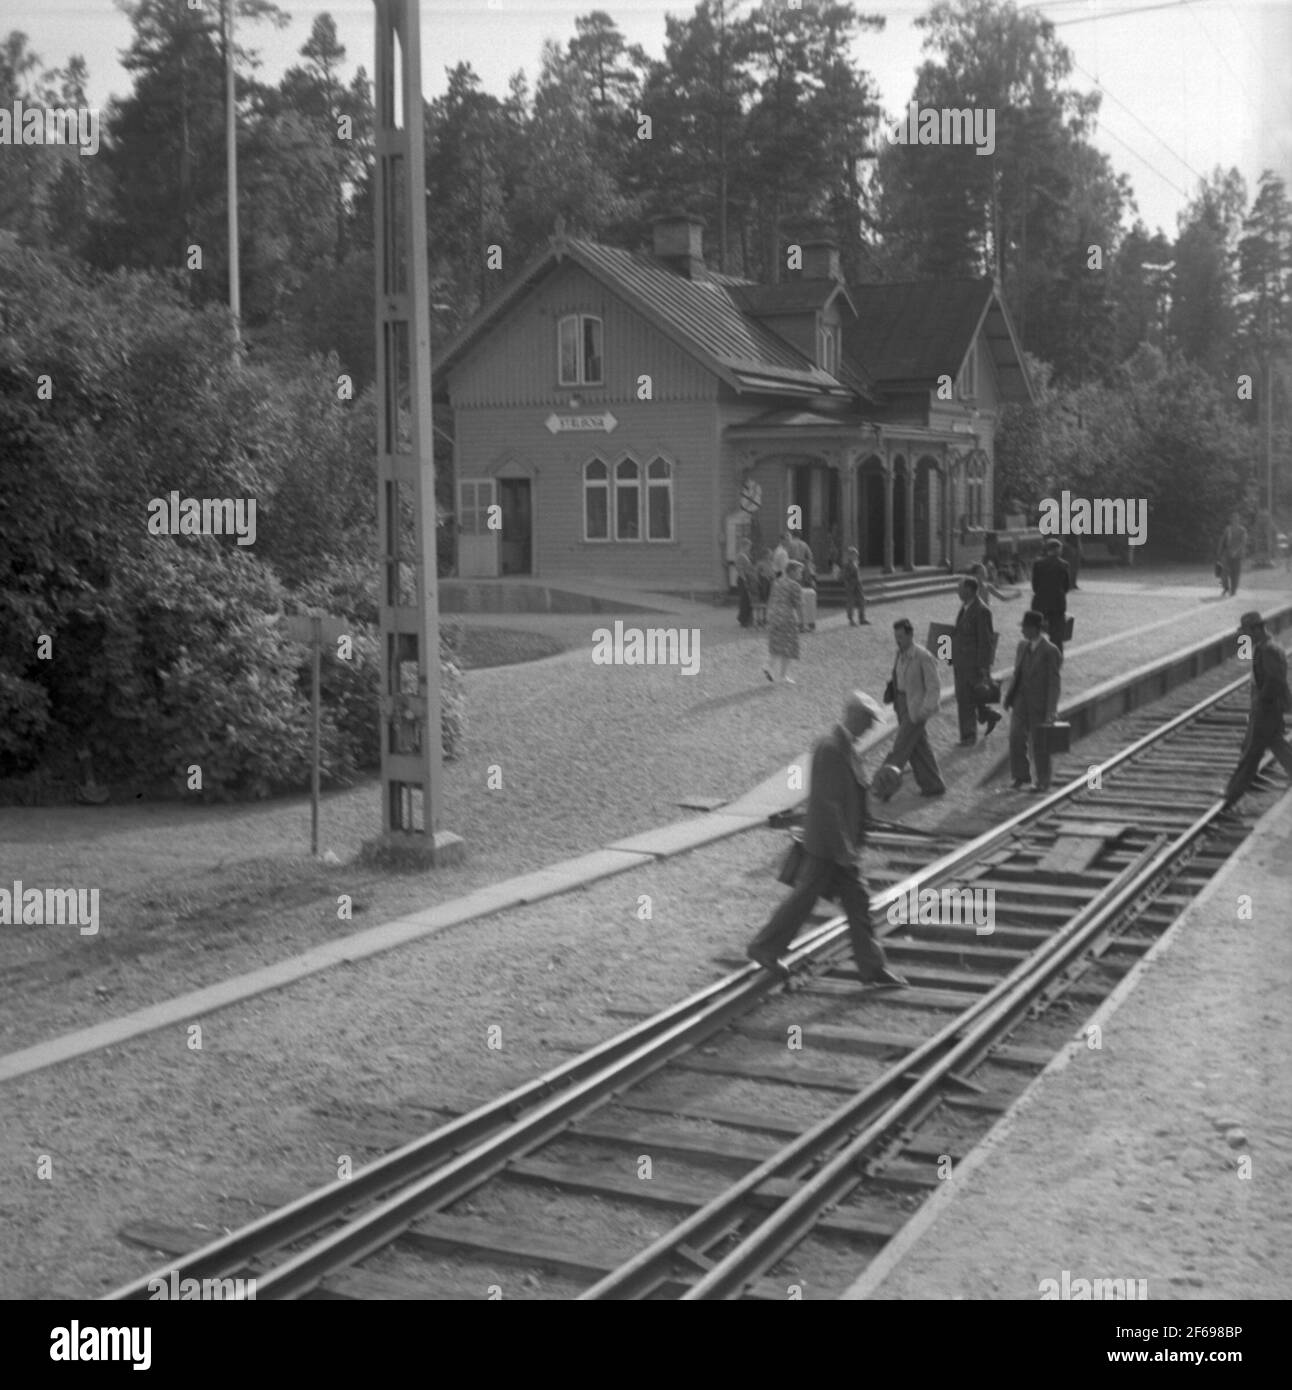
[0,0,1292,791]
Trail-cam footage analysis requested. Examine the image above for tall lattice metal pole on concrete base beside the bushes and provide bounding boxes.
[373,0,463,865]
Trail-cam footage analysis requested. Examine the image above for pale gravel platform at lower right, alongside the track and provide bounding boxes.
[843,795,1292,1300]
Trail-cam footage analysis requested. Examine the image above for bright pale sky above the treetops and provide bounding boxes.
[0,0,1292,236]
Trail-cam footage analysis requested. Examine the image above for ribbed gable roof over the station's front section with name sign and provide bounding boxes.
[433,238,875,399]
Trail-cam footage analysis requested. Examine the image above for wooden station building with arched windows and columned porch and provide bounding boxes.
[433,217,1032,591]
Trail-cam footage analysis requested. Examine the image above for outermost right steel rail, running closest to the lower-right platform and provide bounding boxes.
[681,801,1222,1302]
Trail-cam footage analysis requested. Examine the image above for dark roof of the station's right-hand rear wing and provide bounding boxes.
[844,278,1033,400]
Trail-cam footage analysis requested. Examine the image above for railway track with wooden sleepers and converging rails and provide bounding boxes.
[108,678,1279,1301]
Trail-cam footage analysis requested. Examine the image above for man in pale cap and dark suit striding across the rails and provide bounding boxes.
[748,691,907,988]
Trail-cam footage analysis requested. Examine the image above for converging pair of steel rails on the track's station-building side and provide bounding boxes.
[106,677,1246,1300]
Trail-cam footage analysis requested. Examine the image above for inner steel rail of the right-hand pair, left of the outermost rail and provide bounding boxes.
[580,828,1156,1301]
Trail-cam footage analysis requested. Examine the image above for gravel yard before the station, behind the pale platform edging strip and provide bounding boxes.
[0,570,1286,1049]
